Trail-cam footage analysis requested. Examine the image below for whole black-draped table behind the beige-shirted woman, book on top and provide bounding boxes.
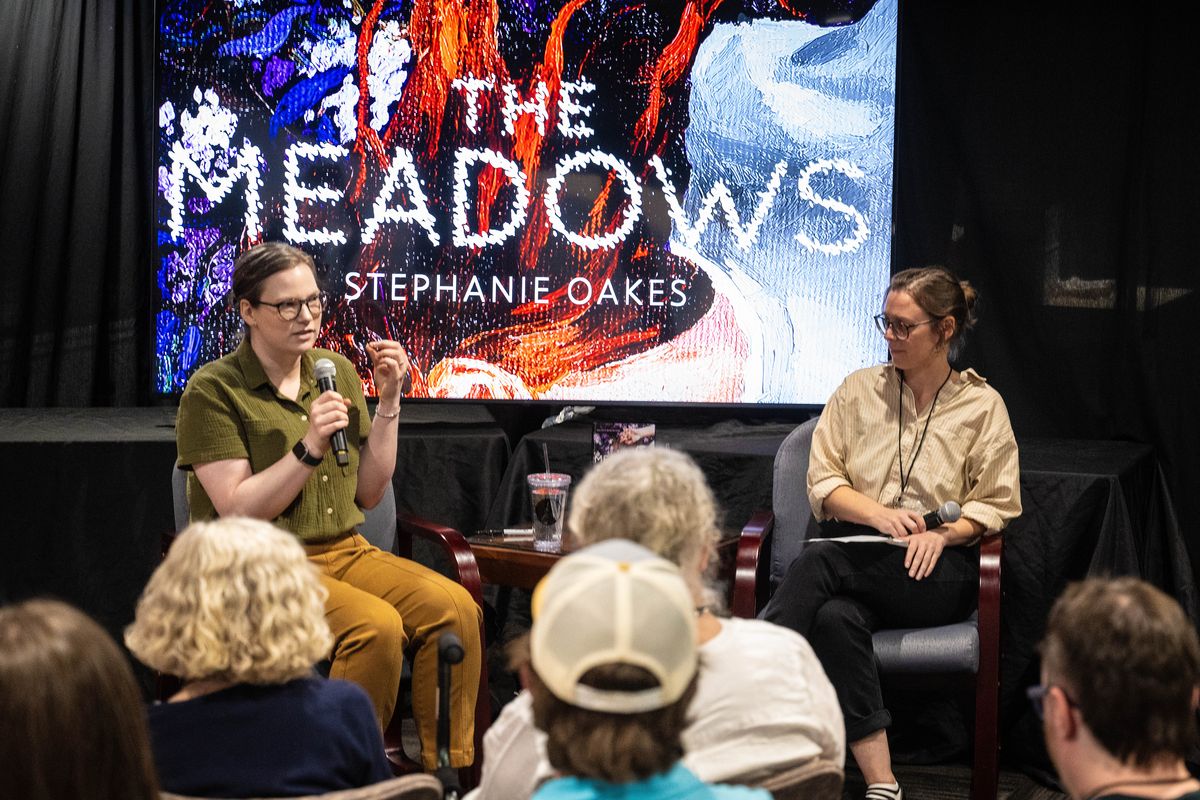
[487,420,1198,768]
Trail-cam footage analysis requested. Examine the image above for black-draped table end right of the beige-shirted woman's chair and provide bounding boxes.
[1000,439,1200,769]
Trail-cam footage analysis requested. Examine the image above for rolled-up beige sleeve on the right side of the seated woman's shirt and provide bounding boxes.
[962,402,1021,533]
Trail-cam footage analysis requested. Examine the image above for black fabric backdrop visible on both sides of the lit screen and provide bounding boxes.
[0,0,1200,652]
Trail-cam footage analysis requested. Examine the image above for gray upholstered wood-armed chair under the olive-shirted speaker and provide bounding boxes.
[160,465,492,788]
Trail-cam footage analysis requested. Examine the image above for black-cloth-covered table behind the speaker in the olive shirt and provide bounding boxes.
[0,403,509,695]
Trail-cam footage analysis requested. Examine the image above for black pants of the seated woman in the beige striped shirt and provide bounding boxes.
[761,531,979,742]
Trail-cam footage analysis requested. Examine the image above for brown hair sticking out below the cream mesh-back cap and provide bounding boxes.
[528,663,696,783]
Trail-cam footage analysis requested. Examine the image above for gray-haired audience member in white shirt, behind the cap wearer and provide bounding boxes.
[468,447,845,800]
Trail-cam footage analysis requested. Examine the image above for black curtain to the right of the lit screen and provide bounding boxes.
[893,2,1200,582]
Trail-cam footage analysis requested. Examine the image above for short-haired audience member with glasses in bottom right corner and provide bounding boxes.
[1028,578,1200,800]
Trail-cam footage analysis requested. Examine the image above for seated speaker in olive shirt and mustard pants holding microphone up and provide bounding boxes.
[175,242,481,770]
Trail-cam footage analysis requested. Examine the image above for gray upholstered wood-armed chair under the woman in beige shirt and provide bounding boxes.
[731,419,1003,800]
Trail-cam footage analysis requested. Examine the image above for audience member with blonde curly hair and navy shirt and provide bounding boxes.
[125,517,391,798]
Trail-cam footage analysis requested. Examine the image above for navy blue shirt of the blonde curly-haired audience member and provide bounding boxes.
[150,678,391,798]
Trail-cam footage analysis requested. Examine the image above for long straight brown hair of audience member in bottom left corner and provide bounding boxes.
[0,600,158,800]
